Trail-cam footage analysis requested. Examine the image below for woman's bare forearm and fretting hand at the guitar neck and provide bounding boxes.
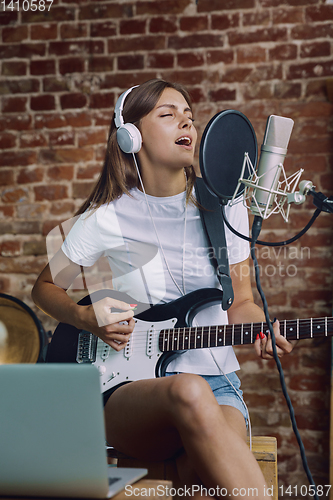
[228,259,294,359]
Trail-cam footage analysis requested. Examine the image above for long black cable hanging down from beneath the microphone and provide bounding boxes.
[250,214,319,500]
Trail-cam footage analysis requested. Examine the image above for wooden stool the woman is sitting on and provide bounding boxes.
[108,436,278,500]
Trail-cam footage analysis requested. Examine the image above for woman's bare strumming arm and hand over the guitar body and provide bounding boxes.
[31,250,134,351]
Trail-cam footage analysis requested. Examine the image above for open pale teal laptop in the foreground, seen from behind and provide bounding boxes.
[0,363,147,498]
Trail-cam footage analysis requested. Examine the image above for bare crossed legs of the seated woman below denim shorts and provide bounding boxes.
[105,374,267,500]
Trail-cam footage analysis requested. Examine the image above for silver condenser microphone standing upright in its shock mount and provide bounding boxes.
[250,115,294,216]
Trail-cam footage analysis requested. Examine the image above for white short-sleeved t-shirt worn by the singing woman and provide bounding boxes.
[62,189,249,375]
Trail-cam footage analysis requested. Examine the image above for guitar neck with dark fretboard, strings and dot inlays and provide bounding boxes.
[159,317,333,352]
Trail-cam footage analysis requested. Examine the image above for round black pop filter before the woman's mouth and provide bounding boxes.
[199,109,258,205]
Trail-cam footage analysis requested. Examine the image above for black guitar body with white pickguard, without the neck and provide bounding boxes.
[46,288,222,392]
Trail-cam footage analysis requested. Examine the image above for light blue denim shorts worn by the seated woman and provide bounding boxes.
[165,372,249,427]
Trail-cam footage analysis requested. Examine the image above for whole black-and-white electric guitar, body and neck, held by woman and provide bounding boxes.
[46,288,333,393]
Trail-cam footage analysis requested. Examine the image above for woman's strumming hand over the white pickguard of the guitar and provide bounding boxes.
[80,297,135,351]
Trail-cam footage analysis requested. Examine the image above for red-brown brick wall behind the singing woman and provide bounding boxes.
[0,0,333,496]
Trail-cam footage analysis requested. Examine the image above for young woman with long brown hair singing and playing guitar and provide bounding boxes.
[32,80,292,499]
